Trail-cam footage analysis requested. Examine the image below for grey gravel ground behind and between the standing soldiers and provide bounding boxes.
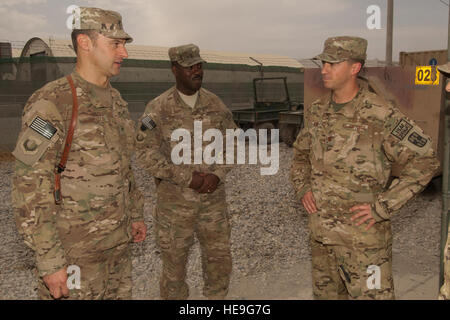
[0,144,441,299]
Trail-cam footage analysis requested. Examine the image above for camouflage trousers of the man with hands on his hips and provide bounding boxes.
[310,213,394,299]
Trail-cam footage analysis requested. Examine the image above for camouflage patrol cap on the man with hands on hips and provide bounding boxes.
[313,36,367,63]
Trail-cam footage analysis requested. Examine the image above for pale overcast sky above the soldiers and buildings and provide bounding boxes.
[0,0,449,60]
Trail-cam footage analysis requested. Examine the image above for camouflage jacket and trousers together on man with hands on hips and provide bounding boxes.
[291,89,439,298]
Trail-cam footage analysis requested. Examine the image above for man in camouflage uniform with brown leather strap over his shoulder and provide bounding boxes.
[12,8,146,299]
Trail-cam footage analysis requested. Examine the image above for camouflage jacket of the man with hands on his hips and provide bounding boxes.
[291,88,439,221]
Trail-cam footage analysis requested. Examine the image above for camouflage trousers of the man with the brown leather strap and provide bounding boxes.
[36,243,132,300]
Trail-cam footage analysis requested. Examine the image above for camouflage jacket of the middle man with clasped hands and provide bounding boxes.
[136,87,237,192]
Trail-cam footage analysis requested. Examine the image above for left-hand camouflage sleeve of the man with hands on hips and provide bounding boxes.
[291,114,311,199]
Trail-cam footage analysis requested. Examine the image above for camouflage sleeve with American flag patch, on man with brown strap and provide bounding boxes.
[12,97,67,276]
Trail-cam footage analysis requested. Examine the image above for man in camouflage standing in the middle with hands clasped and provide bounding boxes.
[136,44,236,299]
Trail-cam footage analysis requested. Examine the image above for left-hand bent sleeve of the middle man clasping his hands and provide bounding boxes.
[135,102,194,187]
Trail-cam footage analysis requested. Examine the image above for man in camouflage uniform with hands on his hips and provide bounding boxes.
[291,37,439,299]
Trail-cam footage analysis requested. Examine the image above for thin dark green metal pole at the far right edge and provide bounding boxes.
[439,0,450,288]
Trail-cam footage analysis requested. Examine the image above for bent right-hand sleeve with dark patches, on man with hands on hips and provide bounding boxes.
[375,107,439,221]
